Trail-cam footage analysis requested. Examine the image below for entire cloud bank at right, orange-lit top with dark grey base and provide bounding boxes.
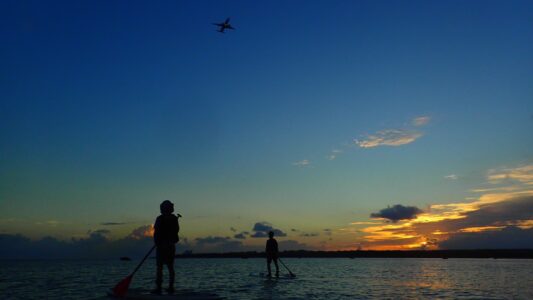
[359,165,533,249]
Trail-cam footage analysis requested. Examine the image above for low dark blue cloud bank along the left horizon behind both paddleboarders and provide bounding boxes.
[0,222,306,259]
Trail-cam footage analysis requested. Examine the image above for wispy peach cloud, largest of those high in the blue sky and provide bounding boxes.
[354,129,423,148]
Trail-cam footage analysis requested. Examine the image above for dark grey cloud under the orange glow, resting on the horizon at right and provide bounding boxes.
[439,226,533,249]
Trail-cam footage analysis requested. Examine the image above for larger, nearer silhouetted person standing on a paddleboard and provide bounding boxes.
[152,200,180,294]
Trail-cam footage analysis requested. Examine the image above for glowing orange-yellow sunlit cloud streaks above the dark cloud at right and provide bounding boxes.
[352,165,533,250]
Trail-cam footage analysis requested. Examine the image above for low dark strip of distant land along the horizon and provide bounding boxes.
[176,249,533,259]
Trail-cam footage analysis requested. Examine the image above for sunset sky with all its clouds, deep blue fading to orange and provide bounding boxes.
[0,0,533,257]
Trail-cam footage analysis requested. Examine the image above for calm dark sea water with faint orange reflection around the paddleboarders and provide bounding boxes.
[0,258,533,299]
